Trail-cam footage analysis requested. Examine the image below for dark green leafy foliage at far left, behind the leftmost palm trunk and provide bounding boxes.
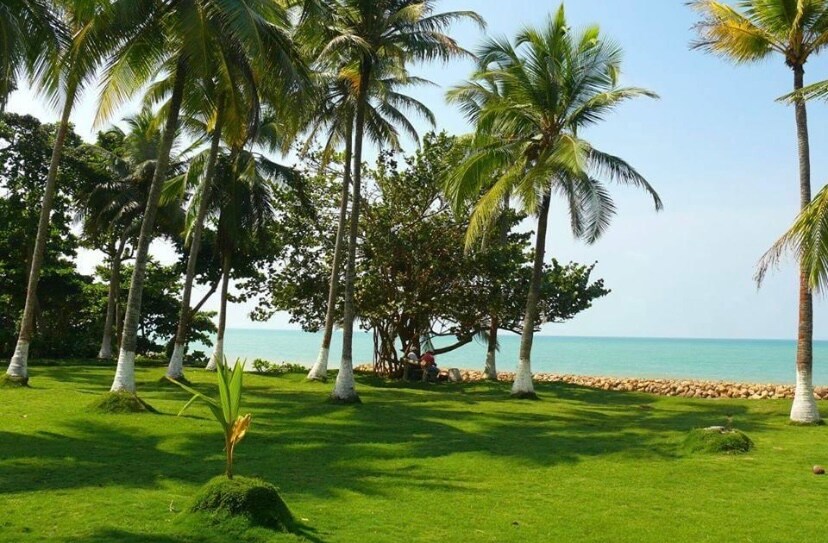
[0,114,106,357]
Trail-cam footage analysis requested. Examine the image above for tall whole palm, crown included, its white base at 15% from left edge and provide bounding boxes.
[98,0,301,392]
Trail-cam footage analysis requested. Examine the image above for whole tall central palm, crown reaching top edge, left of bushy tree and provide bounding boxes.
[320,0,483,403]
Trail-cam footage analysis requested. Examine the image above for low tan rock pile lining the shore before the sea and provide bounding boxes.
[354,364,828,400]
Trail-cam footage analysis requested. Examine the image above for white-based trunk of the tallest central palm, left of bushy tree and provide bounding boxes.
[331,63,371,403]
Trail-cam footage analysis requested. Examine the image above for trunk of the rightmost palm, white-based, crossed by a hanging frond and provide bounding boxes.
[791,66,820,424]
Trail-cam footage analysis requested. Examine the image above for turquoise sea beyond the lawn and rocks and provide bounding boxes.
[201,328,828,385]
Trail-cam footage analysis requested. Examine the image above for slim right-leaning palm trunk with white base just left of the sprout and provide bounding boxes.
[167,97,224,379]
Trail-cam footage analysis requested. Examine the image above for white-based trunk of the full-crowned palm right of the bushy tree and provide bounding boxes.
[512,193,552,398]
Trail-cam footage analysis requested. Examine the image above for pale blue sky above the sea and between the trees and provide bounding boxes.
[9,0,828,339]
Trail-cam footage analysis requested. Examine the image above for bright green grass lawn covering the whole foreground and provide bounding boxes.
[0,365,828,543]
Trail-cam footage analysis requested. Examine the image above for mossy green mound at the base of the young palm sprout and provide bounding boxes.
[189,476,294,531]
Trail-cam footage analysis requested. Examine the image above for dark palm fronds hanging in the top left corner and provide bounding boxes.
[0,0,68,113]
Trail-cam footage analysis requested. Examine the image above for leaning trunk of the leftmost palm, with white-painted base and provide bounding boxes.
[6,83,77,384]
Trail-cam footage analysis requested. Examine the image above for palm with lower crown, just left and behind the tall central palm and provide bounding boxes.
[308,63,435,381]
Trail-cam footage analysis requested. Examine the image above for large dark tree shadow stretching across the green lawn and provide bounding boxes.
[0,367,766,516]
